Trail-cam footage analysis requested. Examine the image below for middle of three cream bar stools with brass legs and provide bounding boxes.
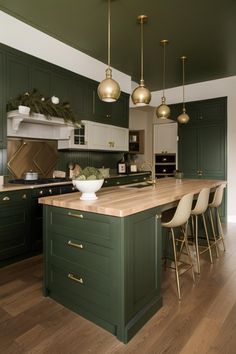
[191,188,213,274]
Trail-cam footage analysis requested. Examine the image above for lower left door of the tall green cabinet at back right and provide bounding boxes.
[179,126,198,178]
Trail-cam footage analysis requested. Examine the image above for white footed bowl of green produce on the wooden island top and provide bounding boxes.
[73,166,104,200]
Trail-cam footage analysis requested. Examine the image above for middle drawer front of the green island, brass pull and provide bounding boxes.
[50,234,112,277]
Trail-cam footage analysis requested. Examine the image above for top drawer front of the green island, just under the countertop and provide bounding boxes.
[49,207,119,248]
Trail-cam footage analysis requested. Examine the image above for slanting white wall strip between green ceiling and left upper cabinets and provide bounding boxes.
[0,11,131,93]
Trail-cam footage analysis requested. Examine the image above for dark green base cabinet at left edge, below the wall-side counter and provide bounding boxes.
[0,190,31,265]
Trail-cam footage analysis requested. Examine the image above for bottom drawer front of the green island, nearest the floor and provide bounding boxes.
[48,262,113,322]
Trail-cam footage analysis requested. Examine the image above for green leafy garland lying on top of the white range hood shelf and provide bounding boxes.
[6,89,79,125]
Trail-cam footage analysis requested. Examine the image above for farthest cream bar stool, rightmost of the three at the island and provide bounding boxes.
[208,184,226,257]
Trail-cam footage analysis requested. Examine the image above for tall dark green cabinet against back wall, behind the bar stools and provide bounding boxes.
[170,97,227,179]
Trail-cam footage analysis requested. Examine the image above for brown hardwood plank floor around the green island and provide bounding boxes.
[0,224,236,354]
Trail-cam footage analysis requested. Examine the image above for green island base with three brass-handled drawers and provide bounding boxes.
[44,205,162,343]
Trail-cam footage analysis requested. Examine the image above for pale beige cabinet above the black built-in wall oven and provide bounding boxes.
[154,123,177,154]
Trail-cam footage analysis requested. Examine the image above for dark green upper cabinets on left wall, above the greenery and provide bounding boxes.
[3,45,129,128]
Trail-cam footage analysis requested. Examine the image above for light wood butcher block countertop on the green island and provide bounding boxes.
[39,178,226,217]
